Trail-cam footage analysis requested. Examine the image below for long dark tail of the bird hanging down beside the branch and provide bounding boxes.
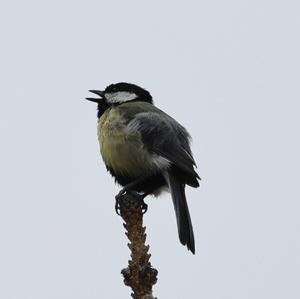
[166,170,195,254]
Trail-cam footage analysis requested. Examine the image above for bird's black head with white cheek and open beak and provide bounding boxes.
[86,82,152,113]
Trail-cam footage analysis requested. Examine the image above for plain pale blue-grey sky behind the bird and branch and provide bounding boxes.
[0,0,300,299]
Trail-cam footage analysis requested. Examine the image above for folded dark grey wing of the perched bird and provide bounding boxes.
[128,111,200,187]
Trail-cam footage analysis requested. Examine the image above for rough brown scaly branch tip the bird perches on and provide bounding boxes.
[119,194,158,299]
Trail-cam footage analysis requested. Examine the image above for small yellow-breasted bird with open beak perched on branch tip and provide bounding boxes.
[86,82,200,254]
